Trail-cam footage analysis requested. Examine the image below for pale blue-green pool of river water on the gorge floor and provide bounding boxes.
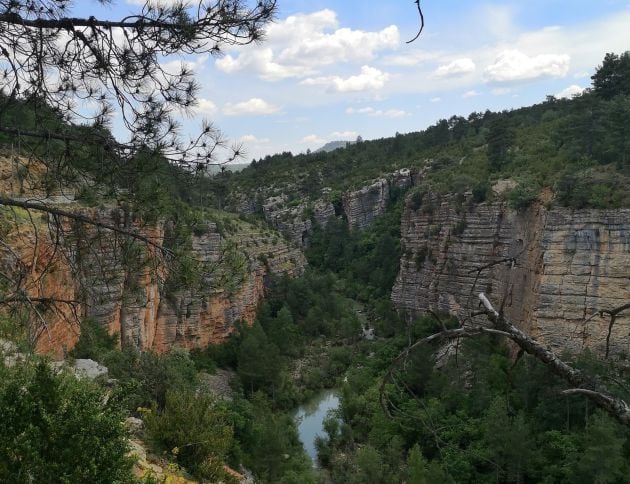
[295,390,339,467]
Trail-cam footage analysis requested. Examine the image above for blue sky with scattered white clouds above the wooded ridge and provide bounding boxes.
[72,0,630,161]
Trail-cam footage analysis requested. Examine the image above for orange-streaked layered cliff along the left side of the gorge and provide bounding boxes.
[0,199,305,357]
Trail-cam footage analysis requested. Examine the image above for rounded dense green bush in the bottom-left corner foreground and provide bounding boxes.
[0,362,133,483]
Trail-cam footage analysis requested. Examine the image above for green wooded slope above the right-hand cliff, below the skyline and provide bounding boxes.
[226,52,630,208]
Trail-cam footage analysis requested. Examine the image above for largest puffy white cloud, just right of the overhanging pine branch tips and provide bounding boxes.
[216,9,400,81]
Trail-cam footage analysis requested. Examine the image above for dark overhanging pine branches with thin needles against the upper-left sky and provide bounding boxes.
[0,0,276,167]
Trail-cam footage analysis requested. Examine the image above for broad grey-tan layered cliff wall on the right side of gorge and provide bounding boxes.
[392,196,630,358]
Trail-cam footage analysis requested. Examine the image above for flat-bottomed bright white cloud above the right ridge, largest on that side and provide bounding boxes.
[485,49,571,82]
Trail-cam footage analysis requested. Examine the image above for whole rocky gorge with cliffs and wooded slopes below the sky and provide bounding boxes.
[0,46,630,484]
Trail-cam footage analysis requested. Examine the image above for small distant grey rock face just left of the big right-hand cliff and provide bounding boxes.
[343,169,414,230]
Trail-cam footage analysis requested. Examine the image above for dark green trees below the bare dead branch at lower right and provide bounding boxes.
[322,330,630,483]
